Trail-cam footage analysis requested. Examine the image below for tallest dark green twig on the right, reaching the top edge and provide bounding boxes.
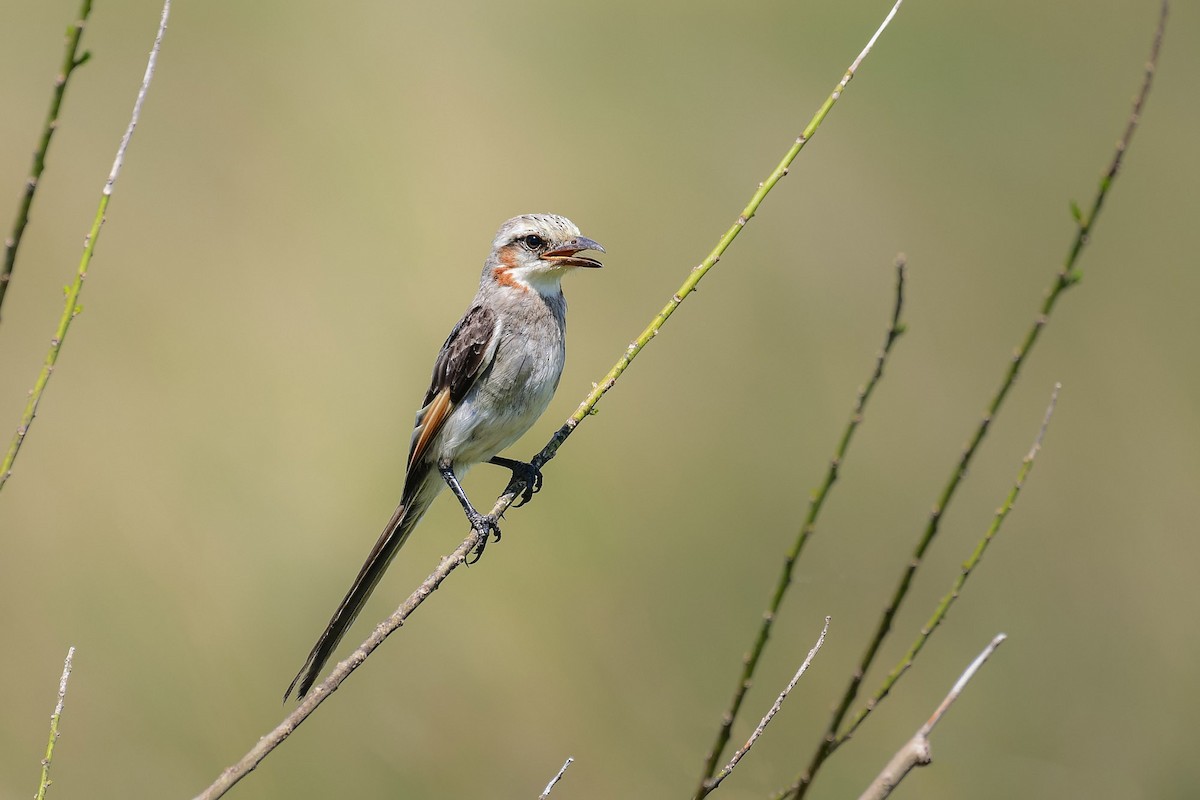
[780,0,1168,800]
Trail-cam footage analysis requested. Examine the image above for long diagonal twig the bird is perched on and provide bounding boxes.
[187,0,902,800]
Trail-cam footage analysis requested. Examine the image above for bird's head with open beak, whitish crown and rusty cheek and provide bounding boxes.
[484,213,605,295]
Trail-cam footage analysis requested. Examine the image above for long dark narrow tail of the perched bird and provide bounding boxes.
[283,492,433,702]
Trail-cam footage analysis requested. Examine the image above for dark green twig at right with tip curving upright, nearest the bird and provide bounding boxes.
[692,255,905,800]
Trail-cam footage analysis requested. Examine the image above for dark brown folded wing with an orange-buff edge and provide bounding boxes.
[408,306,499,479]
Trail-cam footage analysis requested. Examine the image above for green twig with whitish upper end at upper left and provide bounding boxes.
[0,0,170,489]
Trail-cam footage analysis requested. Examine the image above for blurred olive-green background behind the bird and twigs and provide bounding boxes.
[0,0,1200,800]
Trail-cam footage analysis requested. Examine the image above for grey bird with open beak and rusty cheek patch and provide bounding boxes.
[283,213,605,702]
